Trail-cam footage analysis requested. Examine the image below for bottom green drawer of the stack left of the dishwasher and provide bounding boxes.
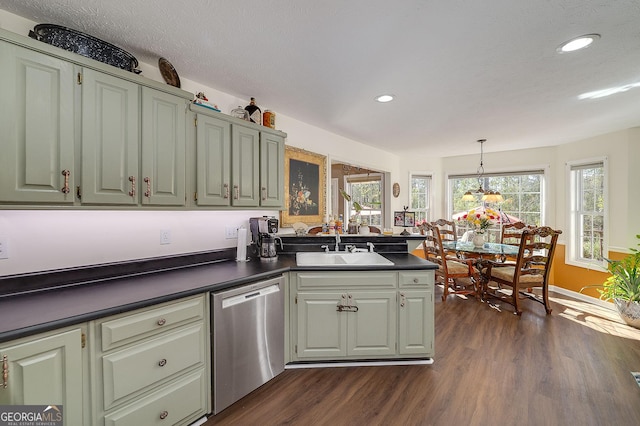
[104,369,207,426]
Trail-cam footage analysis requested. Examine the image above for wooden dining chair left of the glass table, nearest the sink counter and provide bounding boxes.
[420,223,479,302]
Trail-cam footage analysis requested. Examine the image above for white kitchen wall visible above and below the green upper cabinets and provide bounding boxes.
[0,10,399,276]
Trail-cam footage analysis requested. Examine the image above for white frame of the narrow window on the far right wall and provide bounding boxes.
[565,157,609,270]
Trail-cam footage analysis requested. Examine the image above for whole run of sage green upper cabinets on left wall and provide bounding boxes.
[0,29,286,209]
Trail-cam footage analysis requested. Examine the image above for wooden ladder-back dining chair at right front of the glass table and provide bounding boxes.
[482,226,562,315]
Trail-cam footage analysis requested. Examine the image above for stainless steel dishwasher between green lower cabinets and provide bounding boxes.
[211,276,284,414]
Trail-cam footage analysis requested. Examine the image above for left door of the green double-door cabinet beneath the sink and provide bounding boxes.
[297,292,344,359]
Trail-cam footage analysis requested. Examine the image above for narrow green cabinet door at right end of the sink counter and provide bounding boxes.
[398,290,434,356]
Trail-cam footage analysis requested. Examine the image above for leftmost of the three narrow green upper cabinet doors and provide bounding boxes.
[196,114,231,206]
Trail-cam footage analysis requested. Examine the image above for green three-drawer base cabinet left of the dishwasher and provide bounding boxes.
[90,295,211,426]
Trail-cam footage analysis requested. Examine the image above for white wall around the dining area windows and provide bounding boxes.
[400,128,640,251]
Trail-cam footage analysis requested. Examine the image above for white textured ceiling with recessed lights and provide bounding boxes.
[0,0,640,155]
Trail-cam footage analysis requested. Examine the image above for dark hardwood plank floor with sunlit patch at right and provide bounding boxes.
[205,289,640,426]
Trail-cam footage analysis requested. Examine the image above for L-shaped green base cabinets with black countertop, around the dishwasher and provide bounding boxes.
[0,237,435,424]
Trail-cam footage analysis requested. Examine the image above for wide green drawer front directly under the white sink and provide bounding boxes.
[296,271,396,290]
